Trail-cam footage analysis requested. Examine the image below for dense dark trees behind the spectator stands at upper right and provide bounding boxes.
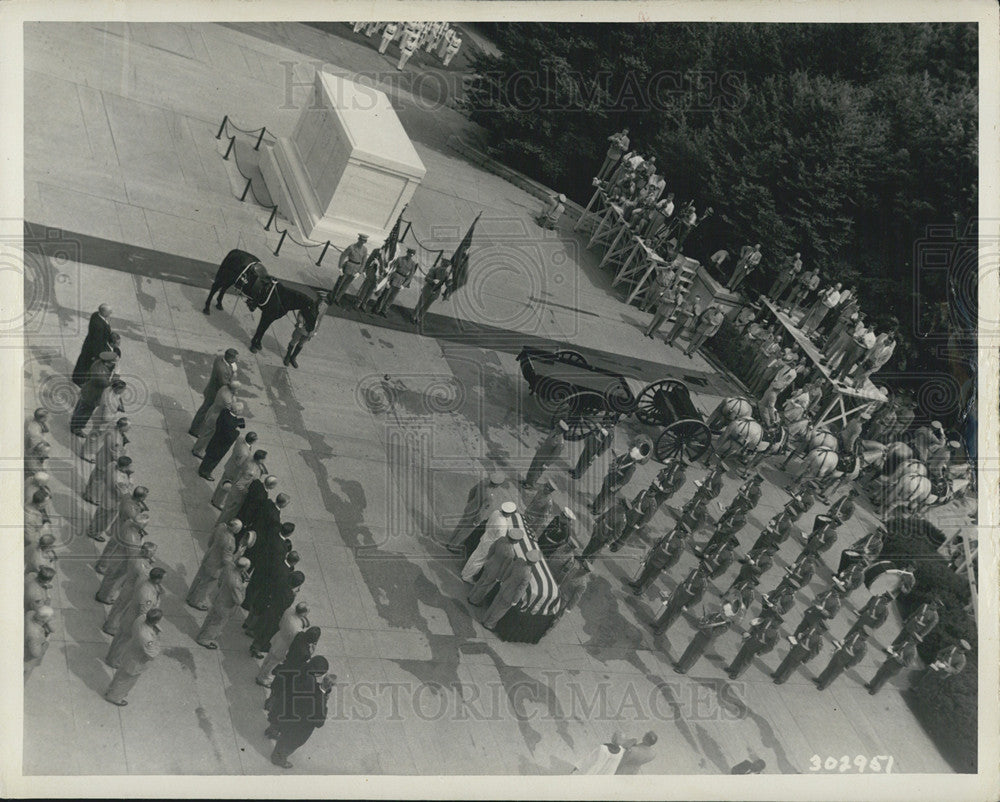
[465,23,978,404]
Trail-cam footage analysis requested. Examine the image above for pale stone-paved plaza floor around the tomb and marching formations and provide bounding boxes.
[17,18,951,775]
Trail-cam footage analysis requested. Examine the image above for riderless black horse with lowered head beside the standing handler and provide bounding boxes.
[201,248,317,353]
